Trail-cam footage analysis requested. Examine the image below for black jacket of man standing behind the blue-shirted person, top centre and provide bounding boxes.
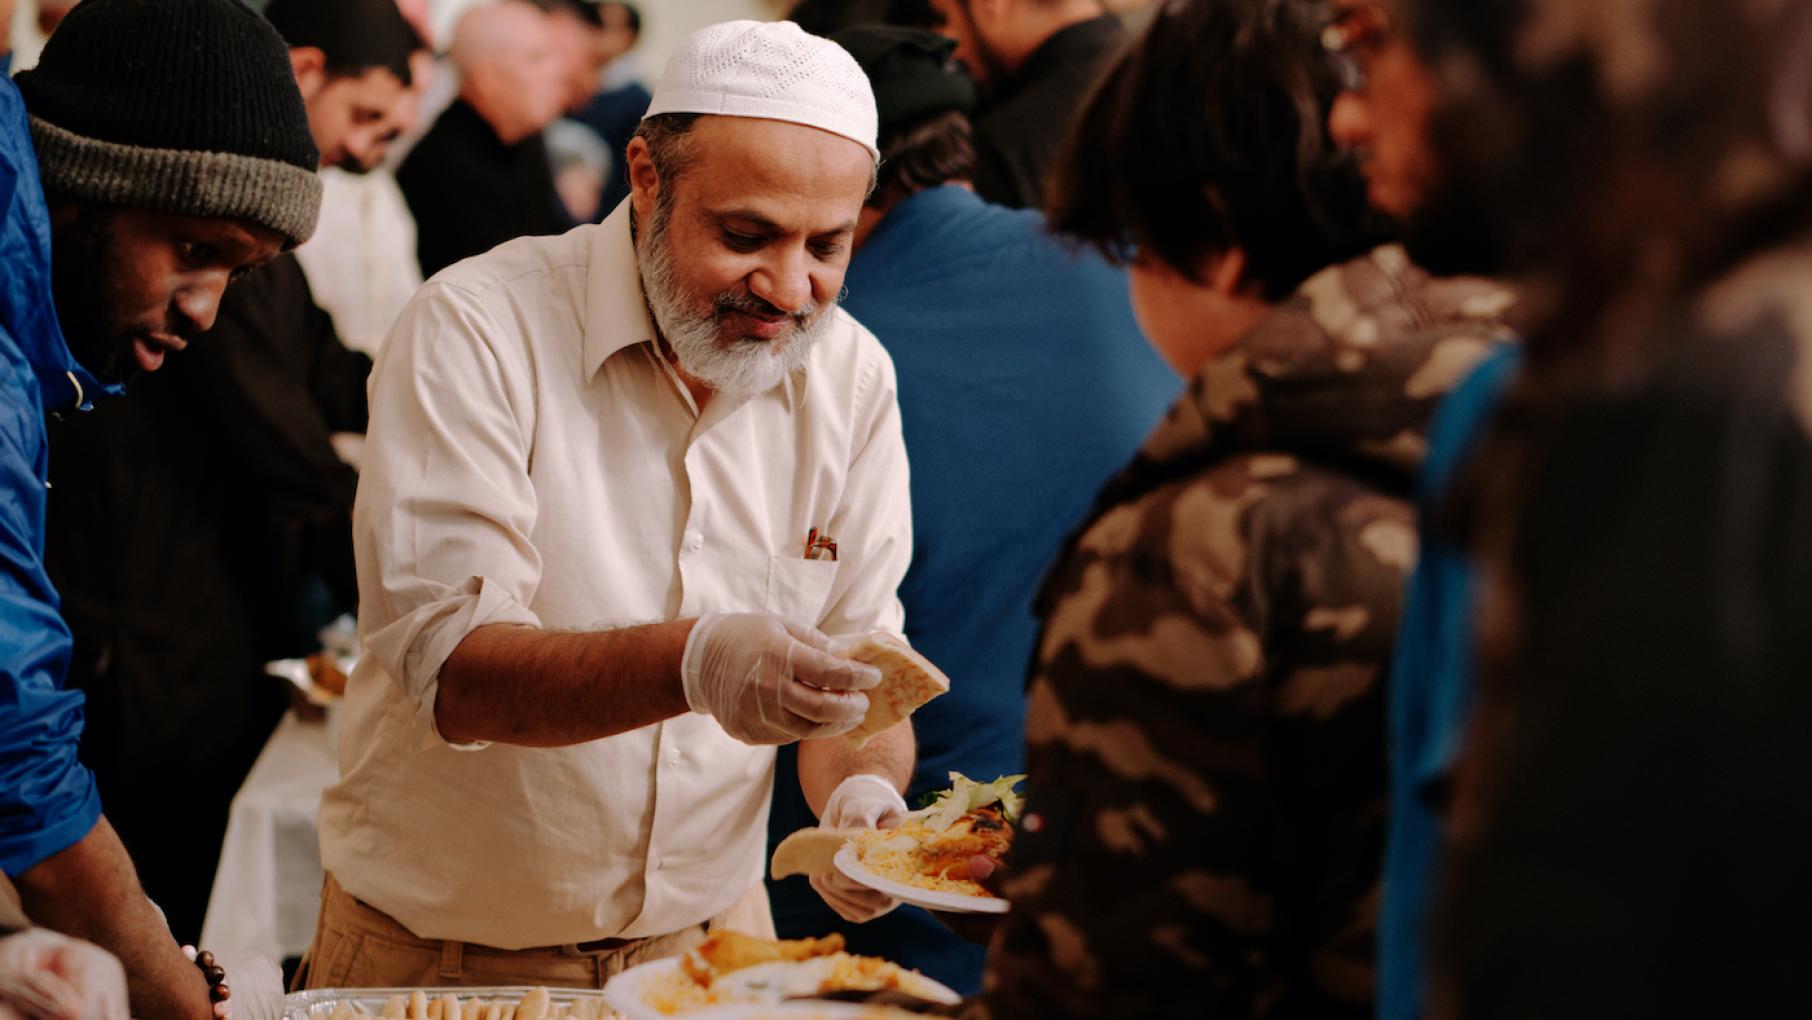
[975,14,1125,208]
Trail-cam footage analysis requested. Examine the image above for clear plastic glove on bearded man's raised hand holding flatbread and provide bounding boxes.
[680,612,881,745]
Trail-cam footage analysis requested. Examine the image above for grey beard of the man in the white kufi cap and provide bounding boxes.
[636,190,832,397]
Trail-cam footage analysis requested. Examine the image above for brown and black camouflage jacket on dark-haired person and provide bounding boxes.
[971,248,1509,1016]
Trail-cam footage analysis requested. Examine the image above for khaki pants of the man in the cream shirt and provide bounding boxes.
[294,875,774,989]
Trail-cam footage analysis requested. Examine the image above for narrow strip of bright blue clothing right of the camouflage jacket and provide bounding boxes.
[1377,344,1520,1020]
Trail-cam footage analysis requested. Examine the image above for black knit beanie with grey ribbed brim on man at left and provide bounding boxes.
[16,0,321,246]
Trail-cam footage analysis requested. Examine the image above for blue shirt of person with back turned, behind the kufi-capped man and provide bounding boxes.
[770,187,1181,993]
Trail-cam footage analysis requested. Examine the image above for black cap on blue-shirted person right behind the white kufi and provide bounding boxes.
[830,25,975,134]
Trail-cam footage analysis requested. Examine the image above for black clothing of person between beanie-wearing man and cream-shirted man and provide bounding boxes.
[45,255,371,933]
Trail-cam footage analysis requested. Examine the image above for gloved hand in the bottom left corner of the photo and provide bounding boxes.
[0,928,130,1020]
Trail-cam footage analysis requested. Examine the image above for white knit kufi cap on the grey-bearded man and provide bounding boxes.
[643,22,881,159]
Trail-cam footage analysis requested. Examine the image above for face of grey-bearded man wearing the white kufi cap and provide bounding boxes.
[631,116,873,395]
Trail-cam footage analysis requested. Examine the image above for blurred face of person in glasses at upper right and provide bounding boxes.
[1323,0,1439,219]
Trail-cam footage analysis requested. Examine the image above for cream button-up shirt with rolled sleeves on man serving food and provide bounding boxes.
[321,203,911,949]
